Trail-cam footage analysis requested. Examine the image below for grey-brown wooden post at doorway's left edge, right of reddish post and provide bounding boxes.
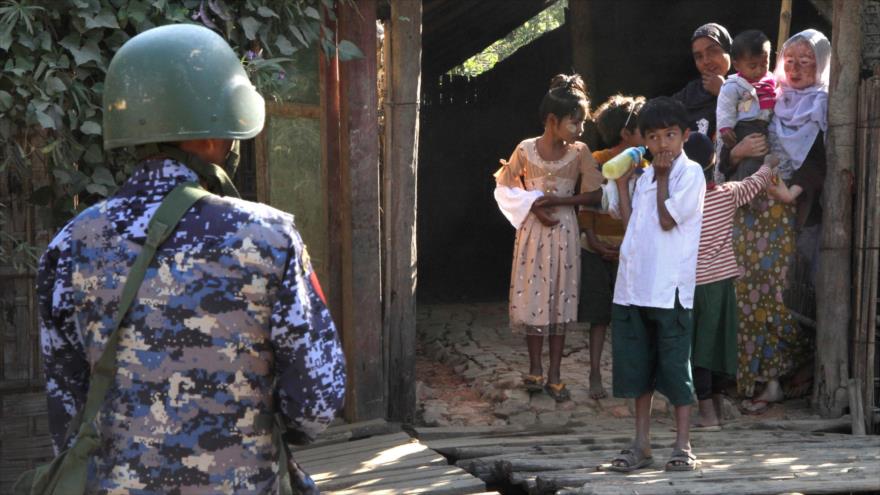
[384,0,422,422]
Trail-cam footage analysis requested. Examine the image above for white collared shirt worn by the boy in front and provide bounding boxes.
[614,151,706,309]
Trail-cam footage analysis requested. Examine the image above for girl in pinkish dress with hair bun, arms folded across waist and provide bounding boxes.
[495,74,603,401]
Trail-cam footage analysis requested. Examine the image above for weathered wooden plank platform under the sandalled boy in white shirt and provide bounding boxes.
[416,425,880,495]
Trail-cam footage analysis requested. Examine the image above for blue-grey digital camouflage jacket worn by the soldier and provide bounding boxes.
[37,160,345,494]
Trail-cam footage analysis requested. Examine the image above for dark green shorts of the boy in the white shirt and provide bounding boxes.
[611,295,694,406]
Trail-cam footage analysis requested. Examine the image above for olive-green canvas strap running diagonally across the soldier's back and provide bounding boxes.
[58,182,210,493]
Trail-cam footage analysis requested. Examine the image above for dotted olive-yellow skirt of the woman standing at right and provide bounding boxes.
[733,193,810,397]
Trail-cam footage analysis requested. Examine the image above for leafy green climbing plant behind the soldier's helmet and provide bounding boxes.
[0,0,361,272]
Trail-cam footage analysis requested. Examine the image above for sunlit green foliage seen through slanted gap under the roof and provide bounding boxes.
[449,0,568,77]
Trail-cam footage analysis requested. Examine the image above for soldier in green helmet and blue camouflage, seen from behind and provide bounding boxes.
[38,25,345,494]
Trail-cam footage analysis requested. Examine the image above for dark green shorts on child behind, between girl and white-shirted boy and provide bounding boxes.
[578,249,617,325]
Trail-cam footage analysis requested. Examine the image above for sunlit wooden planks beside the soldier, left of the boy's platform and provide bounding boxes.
[293,422,486,495]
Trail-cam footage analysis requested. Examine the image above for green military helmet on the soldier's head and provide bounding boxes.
[103,24,265,149]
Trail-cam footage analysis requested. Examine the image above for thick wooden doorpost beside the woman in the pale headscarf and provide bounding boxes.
[813,0,862,417]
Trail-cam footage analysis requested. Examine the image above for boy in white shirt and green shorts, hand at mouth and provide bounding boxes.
[609,97,706,472]
